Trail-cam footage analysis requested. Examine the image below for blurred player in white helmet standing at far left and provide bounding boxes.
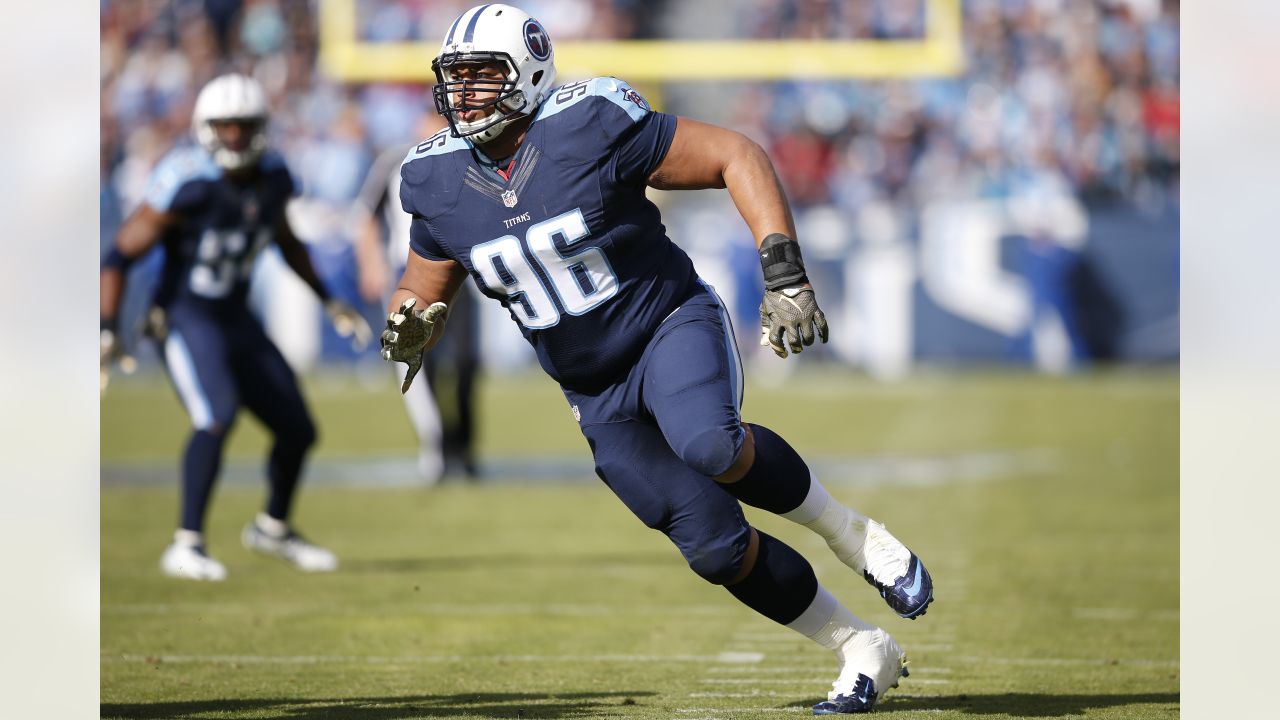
[101,74,372,580]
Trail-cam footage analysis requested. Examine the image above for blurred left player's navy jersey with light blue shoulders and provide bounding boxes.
[143,146,293,311]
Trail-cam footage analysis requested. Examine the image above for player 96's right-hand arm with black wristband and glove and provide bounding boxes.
[648,118,827,357]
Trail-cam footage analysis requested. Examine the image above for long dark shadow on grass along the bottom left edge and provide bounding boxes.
[100,692,655,720]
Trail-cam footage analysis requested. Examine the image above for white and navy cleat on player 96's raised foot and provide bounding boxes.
[827,511,933,620]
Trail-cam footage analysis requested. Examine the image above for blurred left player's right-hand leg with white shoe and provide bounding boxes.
[233,316,338,571]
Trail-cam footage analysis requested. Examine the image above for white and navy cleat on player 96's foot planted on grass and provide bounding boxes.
[813,628,906,715]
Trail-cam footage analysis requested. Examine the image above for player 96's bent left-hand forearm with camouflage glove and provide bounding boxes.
[381,251,467,392]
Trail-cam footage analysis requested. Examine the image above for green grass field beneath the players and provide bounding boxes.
[101,368,1179,720]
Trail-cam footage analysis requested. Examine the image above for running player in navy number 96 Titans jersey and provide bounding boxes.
[381,4,933,714]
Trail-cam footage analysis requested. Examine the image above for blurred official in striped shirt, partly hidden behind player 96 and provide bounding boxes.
[356,113,480,484]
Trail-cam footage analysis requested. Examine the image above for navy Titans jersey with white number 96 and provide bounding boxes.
[401,78,703,392]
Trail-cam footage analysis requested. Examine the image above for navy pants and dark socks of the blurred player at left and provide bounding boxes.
[164,307,316,530]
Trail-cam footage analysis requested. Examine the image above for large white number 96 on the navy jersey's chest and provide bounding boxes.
[471,209,618,331]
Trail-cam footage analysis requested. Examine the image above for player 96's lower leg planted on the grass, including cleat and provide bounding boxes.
[582,421,905,712]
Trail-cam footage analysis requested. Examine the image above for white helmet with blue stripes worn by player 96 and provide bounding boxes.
[431,5,556,142]
